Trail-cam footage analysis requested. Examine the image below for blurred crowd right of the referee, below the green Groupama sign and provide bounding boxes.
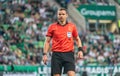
[76,31,120,66]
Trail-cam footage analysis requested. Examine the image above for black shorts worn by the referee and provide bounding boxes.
[51,52,75,76]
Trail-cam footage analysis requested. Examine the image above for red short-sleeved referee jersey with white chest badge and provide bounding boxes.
[46,22,78,52]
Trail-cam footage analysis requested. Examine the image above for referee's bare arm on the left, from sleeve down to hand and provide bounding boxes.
[43,37,51,64]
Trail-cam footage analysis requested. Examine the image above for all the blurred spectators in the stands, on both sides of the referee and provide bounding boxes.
[0,0,120,66]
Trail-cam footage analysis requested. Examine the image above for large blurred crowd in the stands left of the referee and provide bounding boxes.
[0,0,57,65]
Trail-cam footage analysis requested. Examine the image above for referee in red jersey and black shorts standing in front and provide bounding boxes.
[43,8,83,76]
